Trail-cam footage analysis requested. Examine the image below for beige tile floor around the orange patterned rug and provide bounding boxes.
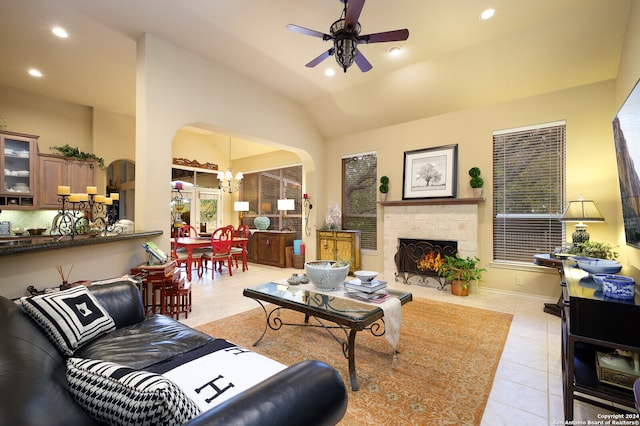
[176,263,610,426]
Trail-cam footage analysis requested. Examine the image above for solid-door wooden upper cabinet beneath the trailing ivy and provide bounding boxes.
[38,154,95,209]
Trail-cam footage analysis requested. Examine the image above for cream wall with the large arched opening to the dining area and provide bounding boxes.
[136,35,324,253]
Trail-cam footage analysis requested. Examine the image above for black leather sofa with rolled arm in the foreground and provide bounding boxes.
[0,282,347,426]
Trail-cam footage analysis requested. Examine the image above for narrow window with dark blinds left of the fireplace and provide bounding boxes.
[342,153,378,250]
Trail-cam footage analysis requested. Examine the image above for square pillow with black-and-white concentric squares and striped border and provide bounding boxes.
[21,286,116,356]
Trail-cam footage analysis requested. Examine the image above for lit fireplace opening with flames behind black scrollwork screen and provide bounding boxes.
[394,238,458,288]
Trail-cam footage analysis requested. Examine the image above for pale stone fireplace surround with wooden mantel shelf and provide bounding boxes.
[381,198,483,286]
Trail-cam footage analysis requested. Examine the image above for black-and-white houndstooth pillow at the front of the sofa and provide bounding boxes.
[67,358,200,426]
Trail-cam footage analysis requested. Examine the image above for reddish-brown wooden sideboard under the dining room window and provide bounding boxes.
[247,231,296,268]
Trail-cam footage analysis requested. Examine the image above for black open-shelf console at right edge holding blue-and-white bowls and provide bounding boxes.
[561,260,640,421]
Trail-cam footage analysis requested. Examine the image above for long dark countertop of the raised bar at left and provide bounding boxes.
[0,231,162,256]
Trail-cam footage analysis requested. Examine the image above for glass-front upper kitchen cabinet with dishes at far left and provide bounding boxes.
[0,131,38,210]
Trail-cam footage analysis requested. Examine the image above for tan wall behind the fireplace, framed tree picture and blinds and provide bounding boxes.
[328,81,621,297]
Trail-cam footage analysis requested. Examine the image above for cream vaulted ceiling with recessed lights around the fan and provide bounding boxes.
[0,0,632,137]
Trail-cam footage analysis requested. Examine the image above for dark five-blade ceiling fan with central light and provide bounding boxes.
[287,0,409,72]
